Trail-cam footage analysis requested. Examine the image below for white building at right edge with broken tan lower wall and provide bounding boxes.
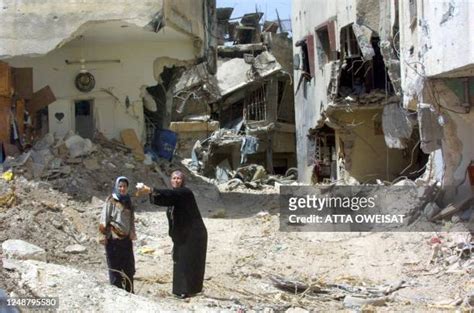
[398,0,474,204]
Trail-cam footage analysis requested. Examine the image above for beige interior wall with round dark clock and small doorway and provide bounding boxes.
[8,40,195,139]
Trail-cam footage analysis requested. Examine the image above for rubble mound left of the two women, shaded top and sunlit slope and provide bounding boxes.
[0,130,191,294]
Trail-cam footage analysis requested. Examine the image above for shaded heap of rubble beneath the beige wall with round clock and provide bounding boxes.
[3,130,189,201]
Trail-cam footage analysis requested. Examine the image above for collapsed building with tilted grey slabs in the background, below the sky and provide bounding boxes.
[170,8,296,181]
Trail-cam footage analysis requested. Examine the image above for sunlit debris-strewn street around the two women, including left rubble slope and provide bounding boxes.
[0,133,474,311]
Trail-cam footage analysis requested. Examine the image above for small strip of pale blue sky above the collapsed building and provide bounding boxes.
[216,0,291,21]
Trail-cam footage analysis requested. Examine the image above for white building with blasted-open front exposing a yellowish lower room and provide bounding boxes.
[292,0,428,184]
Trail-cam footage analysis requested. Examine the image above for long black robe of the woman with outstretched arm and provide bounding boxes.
[150,187,207,295]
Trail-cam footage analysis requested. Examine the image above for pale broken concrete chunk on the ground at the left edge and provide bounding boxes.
[2,239,46,262]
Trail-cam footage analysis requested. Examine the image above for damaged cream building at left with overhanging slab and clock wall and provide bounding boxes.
[0,0,216,158]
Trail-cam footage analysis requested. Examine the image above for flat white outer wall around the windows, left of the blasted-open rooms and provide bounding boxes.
[292,0,356,183]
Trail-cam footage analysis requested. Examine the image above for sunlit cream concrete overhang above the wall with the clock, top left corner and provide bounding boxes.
[0,0,163,57]
